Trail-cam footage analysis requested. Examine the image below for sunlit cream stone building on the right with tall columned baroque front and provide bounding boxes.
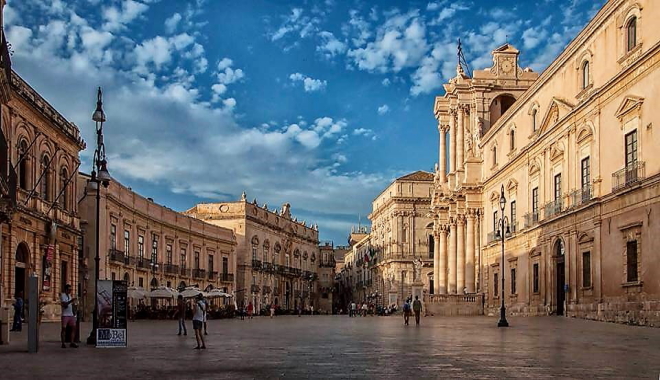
[432,0,660,325]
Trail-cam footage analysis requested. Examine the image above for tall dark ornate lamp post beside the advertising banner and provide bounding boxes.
[87,87,111,344]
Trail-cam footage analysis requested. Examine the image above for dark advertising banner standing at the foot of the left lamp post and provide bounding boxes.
[96,280,128,347]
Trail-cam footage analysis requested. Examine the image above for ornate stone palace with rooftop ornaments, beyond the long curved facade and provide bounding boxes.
[185,193,320,312]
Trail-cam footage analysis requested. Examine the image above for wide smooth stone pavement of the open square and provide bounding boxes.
[0,316,660,380]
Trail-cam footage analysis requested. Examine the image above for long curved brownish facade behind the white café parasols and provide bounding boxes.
[78,174,236,315]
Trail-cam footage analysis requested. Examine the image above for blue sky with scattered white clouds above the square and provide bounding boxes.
[5,0,605,244]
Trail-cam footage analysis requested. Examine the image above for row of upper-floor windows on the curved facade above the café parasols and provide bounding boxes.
[110,224,229,273]
